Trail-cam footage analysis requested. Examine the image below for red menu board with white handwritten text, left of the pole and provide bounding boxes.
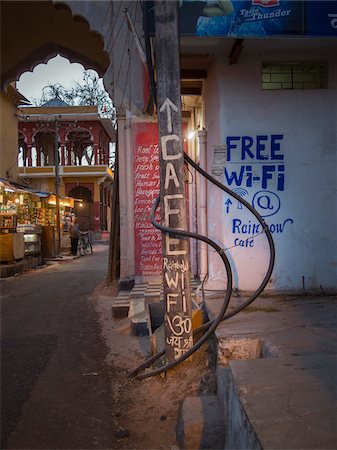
[134,122,162,276]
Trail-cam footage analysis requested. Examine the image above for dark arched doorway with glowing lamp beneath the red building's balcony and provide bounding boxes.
[68,185,94,230]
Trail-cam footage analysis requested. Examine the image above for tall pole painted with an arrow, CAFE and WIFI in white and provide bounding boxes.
[154,0,193,362]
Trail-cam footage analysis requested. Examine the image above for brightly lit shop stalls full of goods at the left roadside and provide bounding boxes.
[0,179,74,276]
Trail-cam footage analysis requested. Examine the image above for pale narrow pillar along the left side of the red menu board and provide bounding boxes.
[117,108,135,279]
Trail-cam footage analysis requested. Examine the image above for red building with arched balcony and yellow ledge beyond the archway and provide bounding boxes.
[18,99,115,236]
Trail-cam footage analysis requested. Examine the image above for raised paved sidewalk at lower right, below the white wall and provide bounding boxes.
[206,296,337,450]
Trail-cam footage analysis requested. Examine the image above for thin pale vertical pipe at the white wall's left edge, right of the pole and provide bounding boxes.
[198,130,208,281]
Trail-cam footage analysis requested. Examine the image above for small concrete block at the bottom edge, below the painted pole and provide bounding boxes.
[176,395,225,450]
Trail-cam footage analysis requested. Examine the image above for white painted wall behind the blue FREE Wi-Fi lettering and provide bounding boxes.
[206,39,337,291]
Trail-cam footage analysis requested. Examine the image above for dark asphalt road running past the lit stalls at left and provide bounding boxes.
[0,245,116,450]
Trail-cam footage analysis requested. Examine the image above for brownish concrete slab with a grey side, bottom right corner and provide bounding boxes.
[225,354,337,450]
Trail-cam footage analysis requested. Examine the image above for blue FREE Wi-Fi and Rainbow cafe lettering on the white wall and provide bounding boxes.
[223,134,294,249]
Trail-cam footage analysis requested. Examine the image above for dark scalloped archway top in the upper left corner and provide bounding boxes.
[0,1,110,89]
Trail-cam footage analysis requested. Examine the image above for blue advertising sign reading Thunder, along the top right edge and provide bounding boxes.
[148,0,337,38]
